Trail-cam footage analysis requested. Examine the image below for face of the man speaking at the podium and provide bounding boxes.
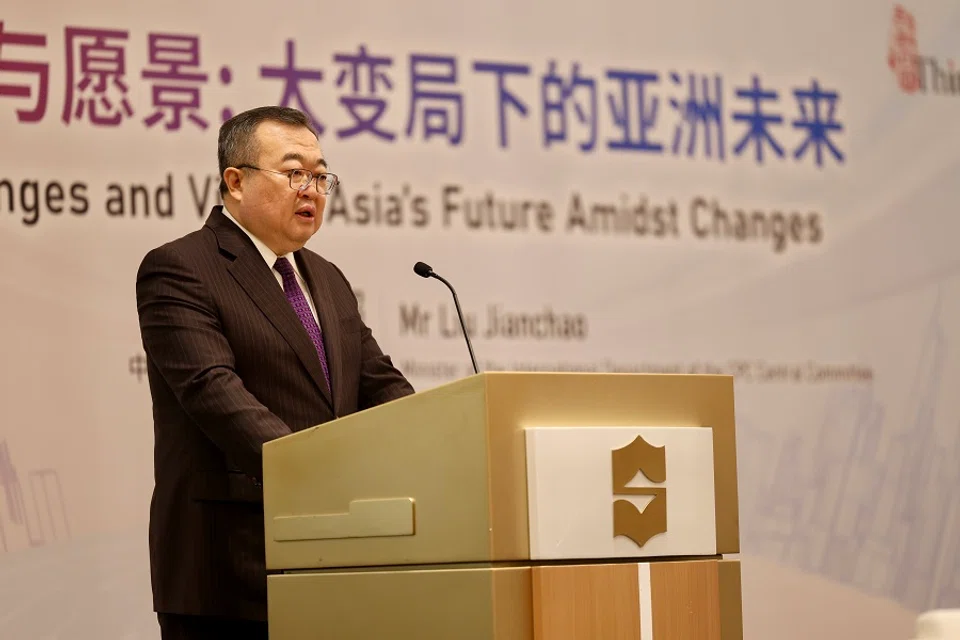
[230,121,327,255]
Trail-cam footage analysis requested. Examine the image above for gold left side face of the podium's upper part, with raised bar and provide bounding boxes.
[263,379,490,570]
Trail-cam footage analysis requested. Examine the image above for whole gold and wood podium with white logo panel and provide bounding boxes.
[263,372,743,640]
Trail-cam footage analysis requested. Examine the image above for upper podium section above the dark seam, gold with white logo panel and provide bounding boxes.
[264,373,740,571]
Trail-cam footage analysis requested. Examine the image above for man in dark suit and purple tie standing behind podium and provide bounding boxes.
[137,107,413,640]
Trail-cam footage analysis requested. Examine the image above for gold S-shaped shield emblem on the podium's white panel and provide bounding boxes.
[612,436,667,547]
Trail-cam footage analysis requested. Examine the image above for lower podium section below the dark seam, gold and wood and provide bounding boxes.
[268,559,743,640]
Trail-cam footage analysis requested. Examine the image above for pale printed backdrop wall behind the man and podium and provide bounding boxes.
[0,0,960,640]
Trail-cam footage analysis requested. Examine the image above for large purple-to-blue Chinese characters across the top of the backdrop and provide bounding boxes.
[0,21,845,167]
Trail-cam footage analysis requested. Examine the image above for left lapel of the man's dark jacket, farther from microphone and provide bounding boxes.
[207,208,333,409]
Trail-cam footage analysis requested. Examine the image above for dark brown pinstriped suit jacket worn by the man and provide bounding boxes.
[137,207,413,620]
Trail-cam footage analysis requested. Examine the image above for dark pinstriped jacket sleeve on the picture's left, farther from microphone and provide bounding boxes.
[136,245,291,479]
